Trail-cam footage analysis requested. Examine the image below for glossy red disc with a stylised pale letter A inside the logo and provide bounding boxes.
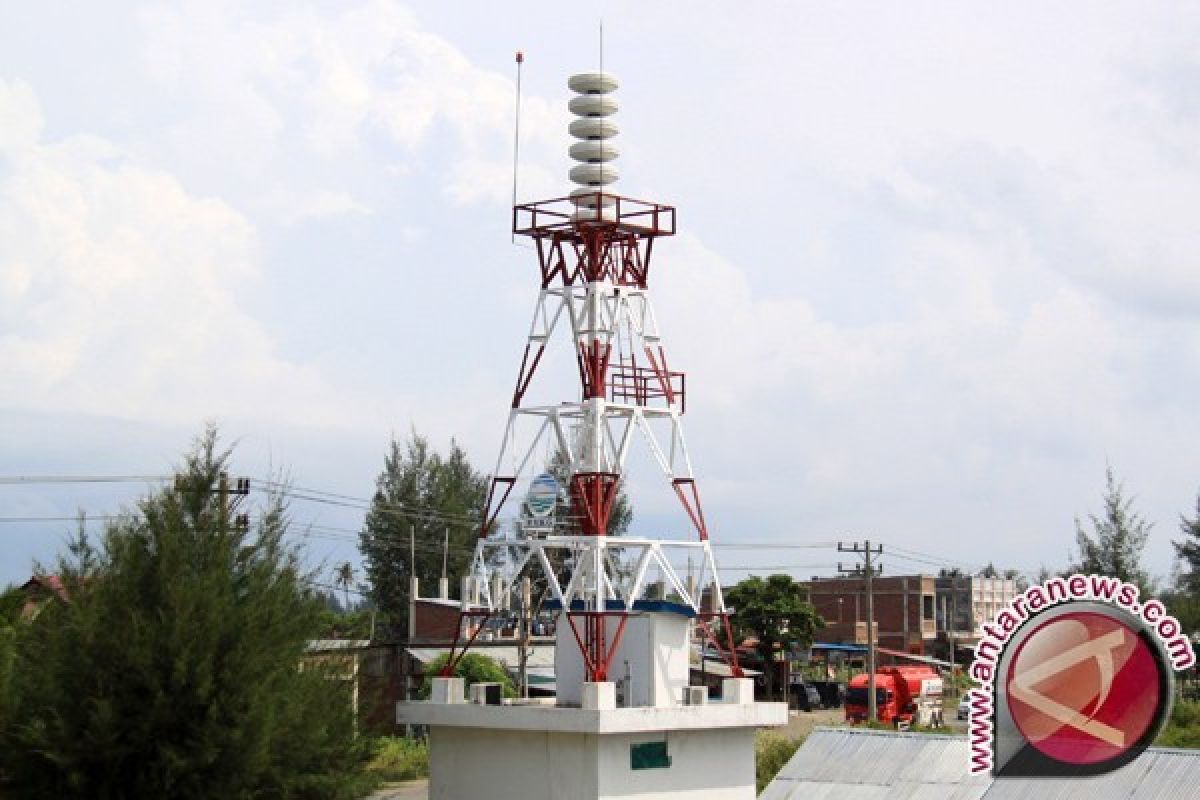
[1006,612,1162,764]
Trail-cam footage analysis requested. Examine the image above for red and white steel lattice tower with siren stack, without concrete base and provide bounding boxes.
[443,72,742,681]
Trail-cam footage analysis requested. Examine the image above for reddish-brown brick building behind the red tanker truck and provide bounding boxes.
[806,575,937,655]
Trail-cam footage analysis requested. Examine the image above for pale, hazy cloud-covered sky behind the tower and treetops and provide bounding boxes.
[0,1,1200,582]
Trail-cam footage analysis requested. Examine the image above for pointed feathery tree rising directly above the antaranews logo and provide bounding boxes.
[1072,467,1153,597]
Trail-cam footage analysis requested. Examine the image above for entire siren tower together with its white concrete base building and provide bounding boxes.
[397,72,787,798]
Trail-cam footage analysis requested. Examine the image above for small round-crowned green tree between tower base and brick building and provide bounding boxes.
[725,575,824,693]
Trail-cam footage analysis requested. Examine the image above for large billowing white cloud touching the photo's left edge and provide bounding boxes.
[0,80,350,423]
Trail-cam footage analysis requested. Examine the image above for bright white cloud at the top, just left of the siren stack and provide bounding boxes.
[135,0,566,219]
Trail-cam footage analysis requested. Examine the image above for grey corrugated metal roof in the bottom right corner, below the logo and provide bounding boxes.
[760,728,1200,800]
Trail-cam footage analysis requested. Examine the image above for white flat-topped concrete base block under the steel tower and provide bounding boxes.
[396,681,787,800]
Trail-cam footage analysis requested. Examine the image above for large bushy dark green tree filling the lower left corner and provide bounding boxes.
[0,429,370,799]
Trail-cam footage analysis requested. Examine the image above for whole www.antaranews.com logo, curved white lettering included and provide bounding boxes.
[968,575,1195,777]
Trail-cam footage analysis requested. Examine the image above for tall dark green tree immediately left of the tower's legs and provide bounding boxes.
[359,433,487,638]
